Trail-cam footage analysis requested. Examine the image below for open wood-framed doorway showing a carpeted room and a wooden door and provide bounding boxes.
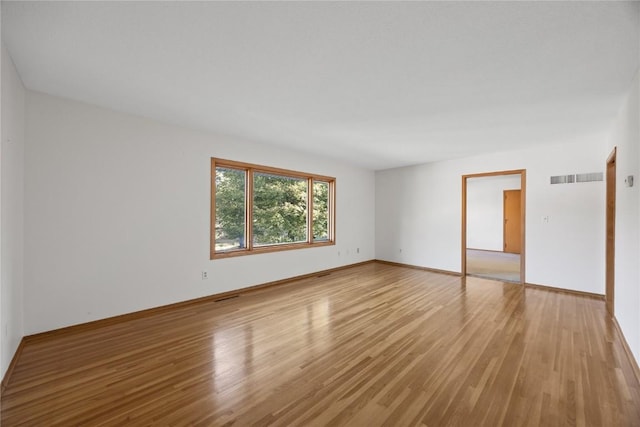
[461,169,526,284]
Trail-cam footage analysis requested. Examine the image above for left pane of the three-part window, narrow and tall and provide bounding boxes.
[216,168,246,252]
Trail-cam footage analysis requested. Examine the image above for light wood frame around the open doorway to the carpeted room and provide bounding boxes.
[460,169,527,285]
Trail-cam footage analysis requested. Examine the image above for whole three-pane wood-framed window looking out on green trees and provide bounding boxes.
[211,159,336,259]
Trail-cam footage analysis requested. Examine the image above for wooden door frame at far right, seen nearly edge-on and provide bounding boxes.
[605,147,618,316]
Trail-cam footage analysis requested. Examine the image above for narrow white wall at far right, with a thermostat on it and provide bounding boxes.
[608,68,640,361]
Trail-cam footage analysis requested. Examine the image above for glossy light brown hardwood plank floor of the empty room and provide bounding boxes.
[2,263,640,427]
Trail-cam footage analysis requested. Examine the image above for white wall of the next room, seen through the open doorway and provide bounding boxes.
[467,175,520,252]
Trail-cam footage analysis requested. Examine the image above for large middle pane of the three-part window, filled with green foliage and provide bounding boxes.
[253,172,307,246]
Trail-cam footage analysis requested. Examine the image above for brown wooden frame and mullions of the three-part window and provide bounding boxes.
[210,157,336,259]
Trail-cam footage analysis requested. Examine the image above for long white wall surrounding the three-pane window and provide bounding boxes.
[25,92,375,334]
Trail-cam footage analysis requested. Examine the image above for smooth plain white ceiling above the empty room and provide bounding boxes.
[2,1,640,169]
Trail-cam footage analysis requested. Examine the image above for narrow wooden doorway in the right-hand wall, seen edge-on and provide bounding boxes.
[605,148,616,316]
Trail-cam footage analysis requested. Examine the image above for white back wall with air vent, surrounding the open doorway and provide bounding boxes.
[376,135,606,294]
